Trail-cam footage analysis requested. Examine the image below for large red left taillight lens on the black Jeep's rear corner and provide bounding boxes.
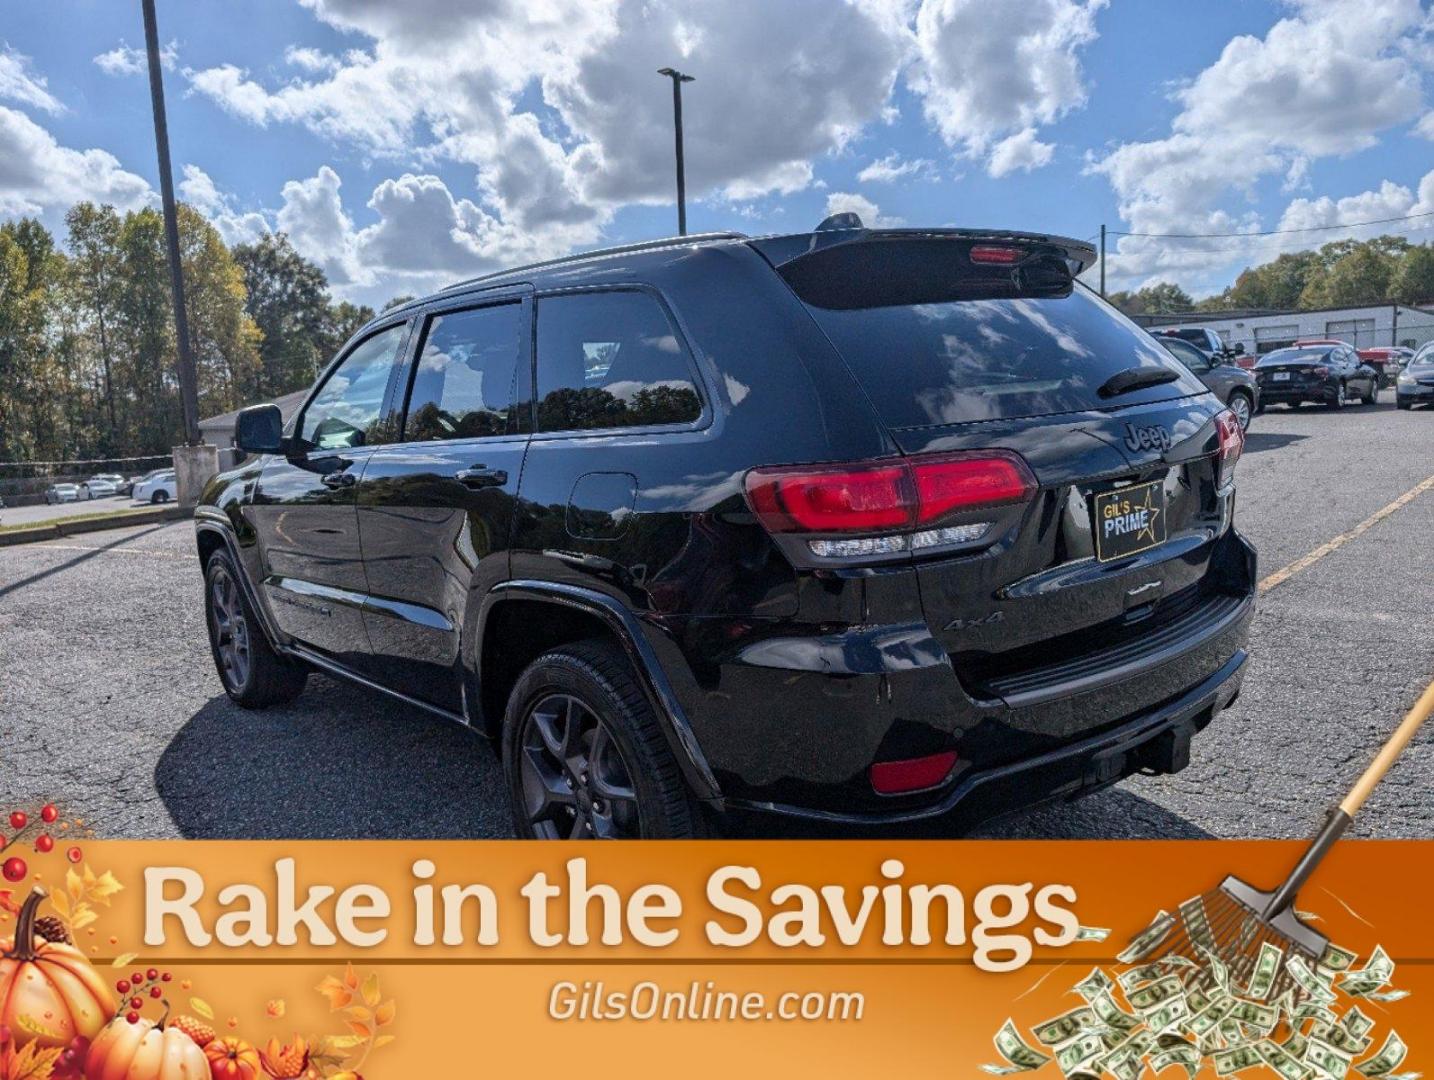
[746,452,1035,534]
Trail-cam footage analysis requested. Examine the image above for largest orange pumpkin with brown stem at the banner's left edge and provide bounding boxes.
[0,886,115,1048]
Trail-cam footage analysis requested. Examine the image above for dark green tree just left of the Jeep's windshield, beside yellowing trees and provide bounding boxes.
[234,232,330,399]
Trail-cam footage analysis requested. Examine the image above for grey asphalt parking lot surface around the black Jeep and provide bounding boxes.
[0,392,1434,838]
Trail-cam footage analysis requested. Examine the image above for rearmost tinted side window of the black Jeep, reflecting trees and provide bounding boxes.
[538,291,703,432]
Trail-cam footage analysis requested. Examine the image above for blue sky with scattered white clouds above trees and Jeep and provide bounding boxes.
[0,0,1434,303]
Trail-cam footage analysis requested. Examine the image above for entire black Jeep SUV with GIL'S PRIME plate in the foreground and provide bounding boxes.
[195,221,1255,838]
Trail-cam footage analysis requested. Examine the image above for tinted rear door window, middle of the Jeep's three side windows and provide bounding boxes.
[403,304,523,442]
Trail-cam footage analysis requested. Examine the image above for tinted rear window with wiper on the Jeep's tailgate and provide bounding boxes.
[807,282,1205,427]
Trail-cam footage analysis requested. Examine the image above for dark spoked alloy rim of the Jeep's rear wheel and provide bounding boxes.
[518,694,642,840]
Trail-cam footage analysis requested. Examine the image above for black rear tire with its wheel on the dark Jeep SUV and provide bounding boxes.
[502,641,706,839]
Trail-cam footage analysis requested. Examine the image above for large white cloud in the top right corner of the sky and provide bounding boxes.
[1087,0,1425,283]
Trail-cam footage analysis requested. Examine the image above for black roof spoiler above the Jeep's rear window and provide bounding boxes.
[749,227,1096,310]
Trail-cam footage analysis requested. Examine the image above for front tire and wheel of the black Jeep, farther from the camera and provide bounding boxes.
[204,549,308,709]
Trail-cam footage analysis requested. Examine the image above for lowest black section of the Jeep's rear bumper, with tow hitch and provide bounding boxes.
[727,648,1249,836]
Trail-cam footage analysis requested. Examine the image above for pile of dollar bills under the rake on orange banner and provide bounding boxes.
[981,896,1420,1080]
